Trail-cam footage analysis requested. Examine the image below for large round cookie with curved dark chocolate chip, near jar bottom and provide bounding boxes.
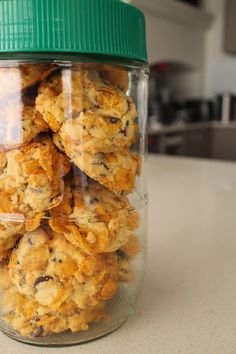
[9,228,119,312]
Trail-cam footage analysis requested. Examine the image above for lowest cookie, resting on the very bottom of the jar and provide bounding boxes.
[1,286,105,338]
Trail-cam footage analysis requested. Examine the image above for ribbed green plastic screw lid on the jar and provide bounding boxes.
[0,0,147,62]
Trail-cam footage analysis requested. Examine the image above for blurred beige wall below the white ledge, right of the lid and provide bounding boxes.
[141,12,204,99]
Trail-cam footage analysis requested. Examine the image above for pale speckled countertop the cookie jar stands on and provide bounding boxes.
[0,156,236,354]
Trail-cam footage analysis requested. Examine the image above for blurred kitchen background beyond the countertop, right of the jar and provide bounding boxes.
[127,0,236,161]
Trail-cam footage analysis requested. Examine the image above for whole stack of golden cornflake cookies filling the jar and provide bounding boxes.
[0,63,140,337]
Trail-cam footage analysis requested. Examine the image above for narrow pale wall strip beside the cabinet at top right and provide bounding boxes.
[204,0,236,97]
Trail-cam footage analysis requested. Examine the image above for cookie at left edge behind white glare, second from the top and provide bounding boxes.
[0,96,49,150]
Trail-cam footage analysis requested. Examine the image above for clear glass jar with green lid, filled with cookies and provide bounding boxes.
[0,0,148,346]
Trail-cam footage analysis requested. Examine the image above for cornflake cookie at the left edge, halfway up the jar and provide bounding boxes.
[0,137,70,225]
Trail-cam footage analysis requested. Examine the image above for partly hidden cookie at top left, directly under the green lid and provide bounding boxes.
[0,63,56,98]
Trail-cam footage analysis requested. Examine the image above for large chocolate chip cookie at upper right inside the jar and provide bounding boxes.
[36,69,137,154]
